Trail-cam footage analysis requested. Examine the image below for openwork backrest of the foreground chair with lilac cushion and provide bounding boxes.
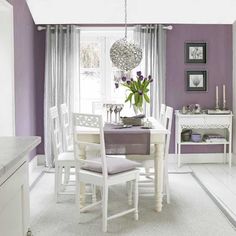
[73,113,108,178]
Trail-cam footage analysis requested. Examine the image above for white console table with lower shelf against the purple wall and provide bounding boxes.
[175,110,233,167]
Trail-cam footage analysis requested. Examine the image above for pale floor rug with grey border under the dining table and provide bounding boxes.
[30,173,236,236]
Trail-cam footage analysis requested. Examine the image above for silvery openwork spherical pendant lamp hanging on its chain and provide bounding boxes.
[110,0,142,71]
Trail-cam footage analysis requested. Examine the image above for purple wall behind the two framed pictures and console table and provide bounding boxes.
[166,25,232,153]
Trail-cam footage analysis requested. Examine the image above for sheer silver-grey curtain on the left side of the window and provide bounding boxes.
[44,25,80,167]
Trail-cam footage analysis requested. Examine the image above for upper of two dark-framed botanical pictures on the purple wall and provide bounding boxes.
[185,43,207,63]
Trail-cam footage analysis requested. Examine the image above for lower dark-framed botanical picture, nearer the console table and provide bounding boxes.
[186,70,207,91]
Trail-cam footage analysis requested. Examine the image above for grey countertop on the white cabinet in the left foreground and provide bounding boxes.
[0,136,41,178]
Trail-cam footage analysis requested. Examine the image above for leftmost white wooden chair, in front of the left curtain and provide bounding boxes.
[50,107,75,202]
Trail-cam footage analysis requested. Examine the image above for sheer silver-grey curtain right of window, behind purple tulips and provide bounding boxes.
[134,25,166,118]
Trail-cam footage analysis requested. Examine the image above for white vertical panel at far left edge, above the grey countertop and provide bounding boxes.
[0,0,15,136]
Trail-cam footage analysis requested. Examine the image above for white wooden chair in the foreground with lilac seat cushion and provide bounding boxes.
[73,114,139,232]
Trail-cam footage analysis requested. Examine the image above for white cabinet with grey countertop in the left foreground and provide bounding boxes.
[0,137,41,236]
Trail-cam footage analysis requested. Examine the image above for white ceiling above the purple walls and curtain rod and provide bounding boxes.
[26,0,236,24]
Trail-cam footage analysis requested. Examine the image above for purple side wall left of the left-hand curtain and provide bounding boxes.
[9,0,45,159]
